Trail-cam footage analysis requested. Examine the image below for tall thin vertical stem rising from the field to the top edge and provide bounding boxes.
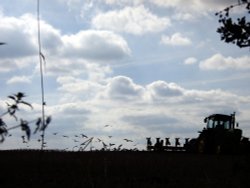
[37,0,45,150]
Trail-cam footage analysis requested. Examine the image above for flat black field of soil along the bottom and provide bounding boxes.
[0,151,250,188]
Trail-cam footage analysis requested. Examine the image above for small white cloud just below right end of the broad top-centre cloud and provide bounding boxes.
[161,33,192,46]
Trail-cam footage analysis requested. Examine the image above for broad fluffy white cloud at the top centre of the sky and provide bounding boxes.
[92,5,170,35]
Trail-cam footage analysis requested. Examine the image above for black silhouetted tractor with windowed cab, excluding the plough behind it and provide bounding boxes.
[184,113,250,154]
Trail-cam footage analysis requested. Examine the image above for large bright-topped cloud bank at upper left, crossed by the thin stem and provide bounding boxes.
[0,14,131,76]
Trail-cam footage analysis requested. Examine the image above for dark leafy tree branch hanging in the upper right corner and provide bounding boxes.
[215,0,250,48]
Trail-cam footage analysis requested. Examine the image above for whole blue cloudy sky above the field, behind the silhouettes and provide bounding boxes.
[0,0,250,150]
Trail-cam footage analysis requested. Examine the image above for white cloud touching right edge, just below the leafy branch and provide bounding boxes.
[199,53,250,70]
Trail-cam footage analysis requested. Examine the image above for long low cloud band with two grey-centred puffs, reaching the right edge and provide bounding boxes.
[57,76,249,106]
